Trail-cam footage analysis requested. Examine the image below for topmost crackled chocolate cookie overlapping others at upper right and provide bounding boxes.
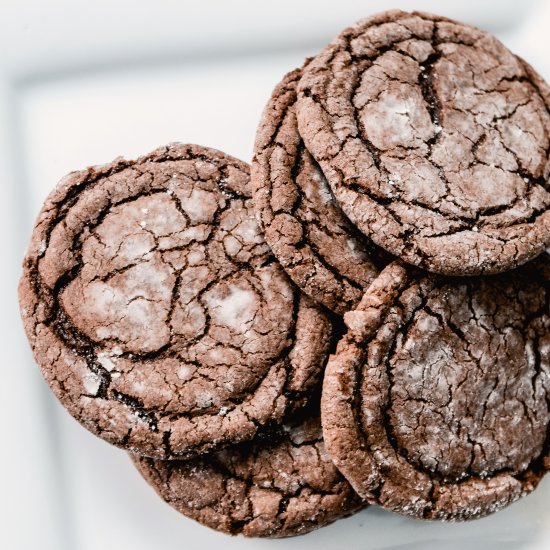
[297,11,550,275]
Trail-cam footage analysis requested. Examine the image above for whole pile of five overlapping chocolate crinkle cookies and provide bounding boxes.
[20,11,550,537]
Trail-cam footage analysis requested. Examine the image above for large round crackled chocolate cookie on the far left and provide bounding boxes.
[20,144,331,458]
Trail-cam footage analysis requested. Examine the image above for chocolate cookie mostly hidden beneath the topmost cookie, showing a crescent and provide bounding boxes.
[251,69,381,314]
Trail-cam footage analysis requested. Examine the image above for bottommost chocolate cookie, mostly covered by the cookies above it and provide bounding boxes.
[133,406,365,537]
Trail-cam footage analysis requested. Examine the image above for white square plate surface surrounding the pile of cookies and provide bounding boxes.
[0,0,550,550]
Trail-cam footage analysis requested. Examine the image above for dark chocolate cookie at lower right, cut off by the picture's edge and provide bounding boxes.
[322,254,550,520]
